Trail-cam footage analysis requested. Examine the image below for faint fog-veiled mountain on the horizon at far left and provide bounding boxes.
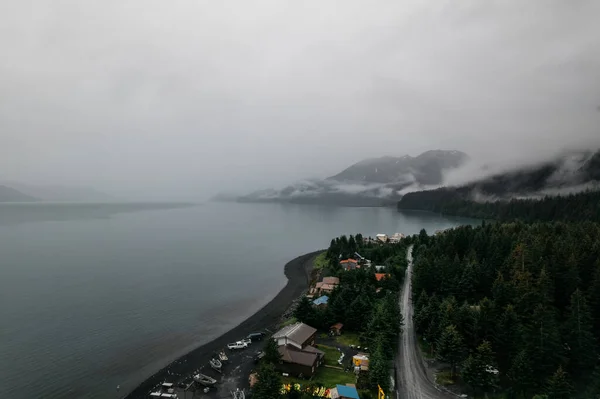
[3,182,115,202]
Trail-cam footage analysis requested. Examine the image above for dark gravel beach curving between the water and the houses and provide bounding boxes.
[125,251,322,399]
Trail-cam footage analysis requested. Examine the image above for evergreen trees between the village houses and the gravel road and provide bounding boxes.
[294,234,407,392]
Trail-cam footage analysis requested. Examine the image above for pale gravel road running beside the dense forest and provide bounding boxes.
[396,246,455,399]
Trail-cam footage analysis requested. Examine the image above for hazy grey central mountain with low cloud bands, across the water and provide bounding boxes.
[230,150,468,206]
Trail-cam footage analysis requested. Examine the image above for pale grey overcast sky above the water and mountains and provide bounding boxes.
[0,0,600,197]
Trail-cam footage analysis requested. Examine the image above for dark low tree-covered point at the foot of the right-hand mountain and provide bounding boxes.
[398,188,600,222]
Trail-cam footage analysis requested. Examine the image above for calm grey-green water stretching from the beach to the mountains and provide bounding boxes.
[0,203,473,398]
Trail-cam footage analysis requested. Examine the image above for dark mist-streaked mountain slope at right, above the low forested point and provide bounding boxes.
[398,150,600,211]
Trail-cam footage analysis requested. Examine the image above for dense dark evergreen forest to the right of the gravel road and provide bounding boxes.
[412,223,600,399]
